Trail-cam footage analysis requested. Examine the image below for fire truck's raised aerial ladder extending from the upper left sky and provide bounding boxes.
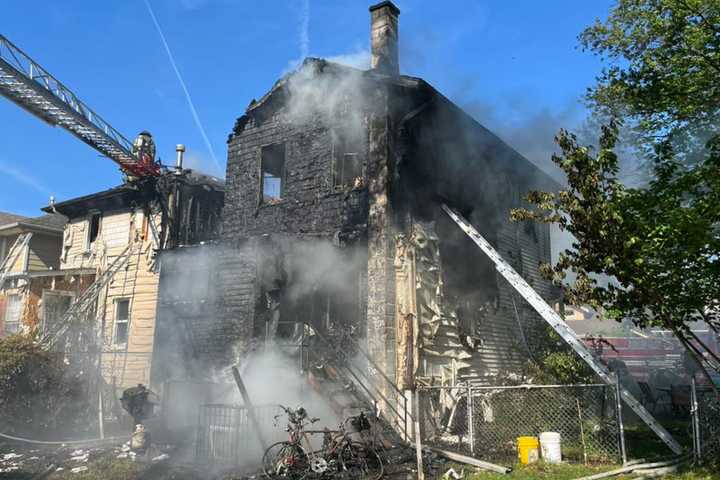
[0,35,157,174]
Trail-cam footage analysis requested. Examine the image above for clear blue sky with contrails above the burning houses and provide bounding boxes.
[0,0,611,215]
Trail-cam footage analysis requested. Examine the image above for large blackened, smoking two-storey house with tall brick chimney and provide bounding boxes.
[159,2,555,420]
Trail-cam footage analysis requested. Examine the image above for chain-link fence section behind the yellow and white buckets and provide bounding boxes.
[419,384,624,462]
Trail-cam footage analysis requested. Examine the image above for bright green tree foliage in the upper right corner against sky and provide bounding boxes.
[580,0,720,161]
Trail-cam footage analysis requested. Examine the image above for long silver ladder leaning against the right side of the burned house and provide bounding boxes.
[442,204,682,454]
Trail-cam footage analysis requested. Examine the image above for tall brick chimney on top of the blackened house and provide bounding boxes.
[370,1,400,76]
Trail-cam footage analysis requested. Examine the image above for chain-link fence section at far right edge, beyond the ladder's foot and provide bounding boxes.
[691,381,720,462]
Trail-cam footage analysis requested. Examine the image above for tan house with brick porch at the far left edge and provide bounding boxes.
[0,213,95,335]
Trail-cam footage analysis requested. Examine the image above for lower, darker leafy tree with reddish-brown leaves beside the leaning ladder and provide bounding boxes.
[511,121,720,384]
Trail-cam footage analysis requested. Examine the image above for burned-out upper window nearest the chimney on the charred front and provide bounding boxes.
[333,128,365,188]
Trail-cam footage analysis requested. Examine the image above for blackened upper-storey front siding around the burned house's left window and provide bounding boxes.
[223,114,367,240]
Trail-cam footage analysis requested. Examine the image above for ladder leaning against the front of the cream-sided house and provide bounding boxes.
[40,243,134,349]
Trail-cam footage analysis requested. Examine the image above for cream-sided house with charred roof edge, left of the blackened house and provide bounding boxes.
[41,172,223,389]
